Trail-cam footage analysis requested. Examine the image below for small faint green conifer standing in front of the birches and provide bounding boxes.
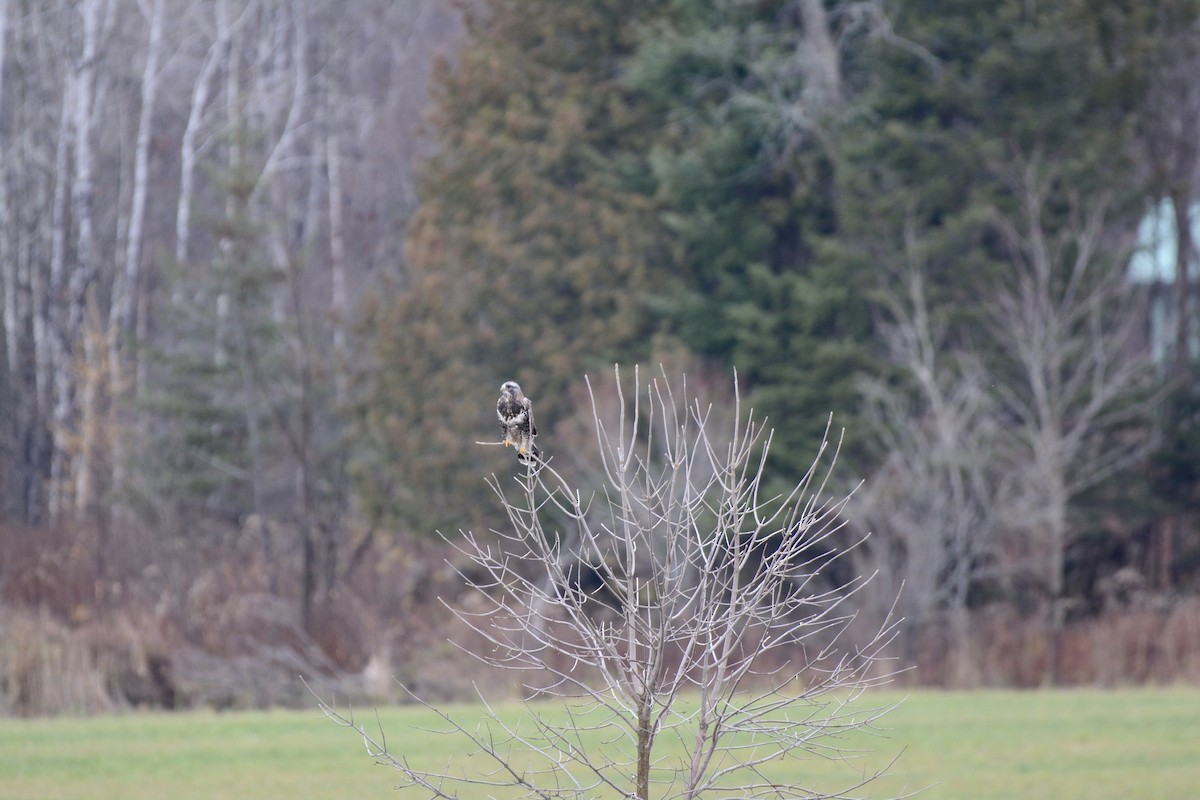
[134,169,282,530]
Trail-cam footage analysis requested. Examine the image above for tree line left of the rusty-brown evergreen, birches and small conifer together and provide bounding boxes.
[0,0,461,625]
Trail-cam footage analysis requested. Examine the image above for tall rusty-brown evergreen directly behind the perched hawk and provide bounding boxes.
[359,0,662,530]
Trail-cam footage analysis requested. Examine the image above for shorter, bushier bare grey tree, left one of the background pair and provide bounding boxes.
[851,261,1025,685]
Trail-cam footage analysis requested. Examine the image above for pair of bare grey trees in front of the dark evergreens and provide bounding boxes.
[856,150,1151,682]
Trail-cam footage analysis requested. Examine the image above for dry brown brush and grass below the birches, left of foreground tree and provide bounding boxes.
[0,527,496,715]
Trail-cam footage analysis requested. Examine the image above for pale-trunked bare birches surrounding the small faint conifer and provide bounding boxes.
[0,0,449,532]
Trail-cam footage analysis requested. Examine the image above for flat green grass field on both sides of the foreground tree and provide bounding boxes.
[0,688,1200,800]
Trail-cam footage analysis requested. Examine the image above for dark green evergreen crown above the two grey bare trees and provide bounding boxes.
[840,0,1136,315]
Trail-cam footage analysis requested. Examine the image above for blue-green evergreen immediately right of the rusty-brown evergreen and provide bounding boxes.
[629,1,870,477]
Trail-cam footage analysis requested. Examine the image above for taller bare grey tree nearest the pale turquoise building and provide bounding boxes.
[991,151,1152,678]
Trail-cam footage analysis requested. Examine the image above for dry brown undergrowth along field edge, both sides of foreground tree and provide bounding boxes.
[0,513,1200,716]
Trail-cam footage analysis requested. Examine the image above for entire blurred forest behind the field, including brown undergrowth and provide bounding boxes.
[0,0,1200,714]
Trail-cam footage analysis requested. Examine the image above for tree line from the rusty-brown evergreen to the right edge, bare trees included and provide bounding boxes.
[368,0,1200,678]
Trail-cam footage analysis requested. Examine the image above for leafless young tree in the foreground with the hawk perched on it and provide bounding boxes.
[322,371,894,799]
